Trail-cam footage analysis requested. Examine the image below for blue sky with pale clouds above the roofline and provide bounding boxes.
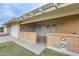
[0,3,44,25]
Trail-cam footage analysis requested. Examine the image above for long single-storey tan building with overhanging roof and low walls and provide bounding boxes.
[5,3,79,54]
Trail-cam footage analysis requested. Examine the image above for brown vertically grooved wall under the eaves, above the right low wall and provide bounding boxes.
[58,15,79,34]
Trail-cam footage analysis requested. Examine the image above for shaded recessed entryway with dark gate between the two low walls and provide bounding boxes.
[35,20,58,45]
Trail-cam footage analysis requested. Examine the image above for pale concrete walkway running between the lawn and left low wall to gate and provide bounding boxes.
[0,36,46,54]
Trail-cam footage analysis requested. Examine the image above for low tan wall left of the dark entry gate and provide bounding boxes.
[20,32,37,44]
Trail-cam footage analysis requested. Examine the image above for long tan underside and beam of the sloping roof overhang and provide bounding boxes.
[21,3,79,24]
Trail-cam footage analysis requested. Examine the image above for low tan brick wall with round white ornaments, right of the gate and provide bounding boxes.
[47,33,79,53]
